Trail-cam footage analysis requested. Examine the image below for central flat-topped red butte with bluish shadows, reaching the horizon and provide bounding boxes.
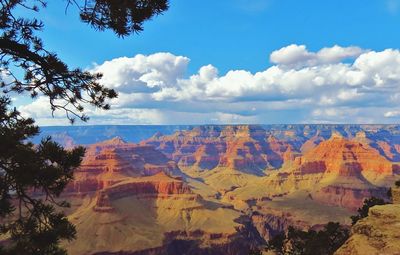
[142,126,289,175]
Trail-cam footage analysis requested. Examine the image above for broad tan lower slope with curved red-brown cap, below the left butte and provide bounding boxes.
[66,173,258,255]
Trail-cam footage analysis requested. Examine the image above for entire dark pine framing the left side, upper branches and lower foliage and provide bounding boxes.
[0,0,168,255]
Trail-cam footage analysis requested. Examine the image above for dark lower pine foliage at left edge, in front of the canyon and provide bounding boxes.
[0,97,84,254]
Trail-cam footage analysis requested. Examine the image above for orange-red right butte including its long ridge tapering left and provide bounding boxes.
[228,134,397,211]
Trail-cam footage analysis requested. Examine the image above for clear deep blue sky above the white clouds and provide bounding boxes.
[42,0,400,72]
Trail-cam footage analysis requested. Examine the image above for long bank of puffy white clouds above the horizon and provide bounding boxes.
[20,44,400,124]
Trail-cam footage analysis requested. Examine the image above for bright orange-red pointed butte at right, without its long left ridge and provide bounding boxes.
[289,134,394,210]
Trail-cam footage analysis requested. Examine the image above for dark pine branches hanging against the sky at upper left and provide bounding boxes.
[0,0,168,122]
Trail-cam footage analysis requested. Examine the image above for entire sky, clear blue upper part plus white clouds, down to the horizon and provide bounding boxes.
[10,0,400,126]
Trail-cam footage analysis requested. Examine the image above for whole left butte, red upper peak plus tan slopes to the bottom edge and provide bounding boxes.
[64,138,258,255]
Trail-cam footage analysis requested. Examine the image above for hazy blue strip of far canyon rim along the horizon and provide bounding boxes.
[32,124,400,144]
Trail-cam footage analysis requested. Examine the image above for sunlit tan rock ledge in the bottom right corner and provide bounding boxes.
[335,204,400,255]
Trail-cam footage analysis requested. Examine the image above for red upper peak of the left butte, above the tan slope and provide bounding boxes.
[67,137,180,192]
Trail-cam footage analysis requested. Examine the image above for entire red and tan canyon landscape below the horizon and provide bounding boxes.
[47,125,400,255]
